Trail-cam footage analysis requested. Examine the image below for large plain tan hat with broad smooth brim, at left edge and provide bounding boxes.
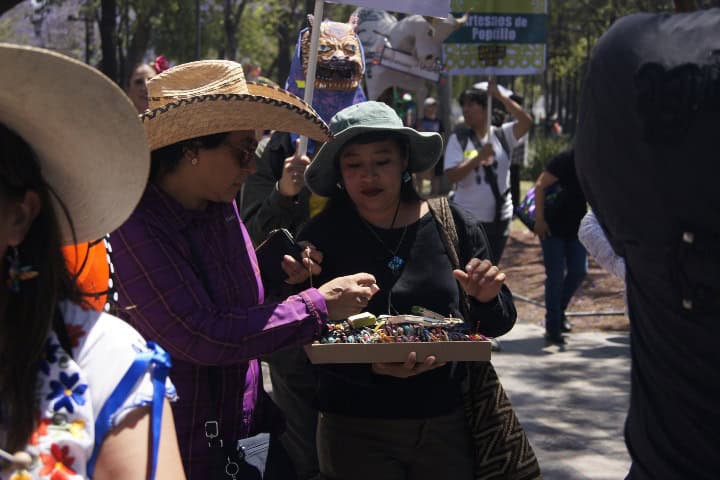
[0,43,150,244]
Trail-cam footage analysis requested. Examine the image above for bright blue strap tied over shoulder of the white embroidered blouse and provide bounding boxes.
[87,341,172,479]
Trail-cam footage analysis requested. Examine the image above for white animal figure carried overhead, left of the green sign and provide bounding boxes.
[355,8,467,116]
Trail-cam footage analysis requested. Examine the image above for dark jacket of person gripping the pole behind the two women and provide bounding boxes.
[241,132,309,245]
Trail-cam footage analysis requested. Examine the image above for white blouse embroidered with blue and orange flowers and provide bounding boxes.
[0,302,177,480]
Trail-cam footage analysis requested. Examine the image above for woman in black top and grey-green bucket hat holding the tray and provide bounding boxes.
[299,102,516,480]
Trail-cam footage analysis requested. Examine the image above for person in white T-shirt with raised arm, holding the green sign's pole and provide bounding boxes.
[445,81,532,263]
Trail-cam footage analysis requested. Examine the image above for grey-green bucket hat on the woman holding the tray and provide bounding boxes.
[305,102,443,197]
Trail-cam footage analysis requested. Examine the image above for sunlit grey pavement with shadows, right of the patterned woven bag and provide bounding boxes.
[493,323,630,480]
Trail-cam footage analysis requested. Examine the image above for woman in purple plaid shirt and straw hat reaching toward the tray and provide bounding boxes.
[113,60,377,479]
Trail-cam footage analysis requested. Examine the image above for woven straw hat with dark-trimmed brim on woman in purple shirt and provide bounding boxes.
[141,60,329,150]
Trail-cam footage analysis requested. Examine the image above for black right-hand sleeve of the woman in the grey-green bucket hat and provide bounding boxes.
[450,204,517,337]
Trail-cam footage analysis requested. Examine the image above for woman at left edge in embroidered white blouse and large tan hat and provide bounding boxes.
[0,44,183,480]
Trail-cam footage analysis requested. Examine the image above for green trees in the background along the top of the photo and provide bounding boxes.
[0,0,720,86]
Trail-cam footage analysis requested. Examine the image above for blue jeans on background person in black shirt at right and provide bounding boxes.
[540,236,587,335]
